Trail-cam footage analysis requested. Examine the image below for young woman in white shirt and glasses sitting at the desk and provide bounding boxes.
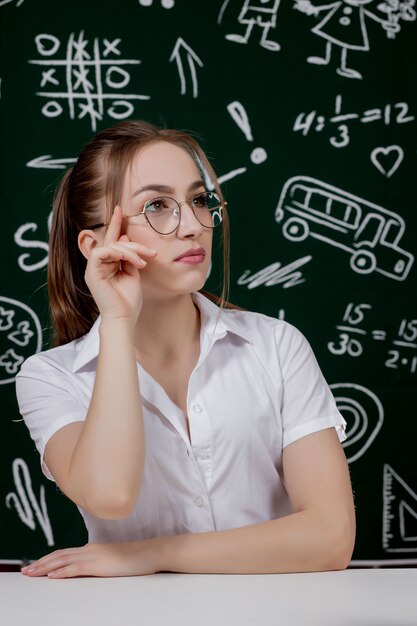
[17,121,355,578]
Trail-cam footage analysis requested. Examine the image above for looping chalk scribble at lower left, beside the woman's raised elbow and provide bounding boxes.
[6,459,55,546]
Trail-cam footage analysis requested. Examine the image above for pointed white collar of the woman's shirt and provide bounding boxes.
[72,292,252,372]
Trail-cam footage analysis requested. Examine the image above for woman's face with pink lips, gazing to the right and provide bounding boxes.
[120,141,213,299]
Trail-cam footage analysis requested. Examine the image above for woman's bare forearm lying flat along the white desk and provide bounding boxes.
[157,510,355,574]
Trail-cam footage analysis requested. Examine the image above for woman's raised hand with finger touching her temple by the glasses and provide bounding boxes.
[85,206,157,326]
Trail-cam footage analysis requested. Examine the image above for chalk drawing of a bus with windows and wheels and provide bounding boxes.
[275,176,414,280]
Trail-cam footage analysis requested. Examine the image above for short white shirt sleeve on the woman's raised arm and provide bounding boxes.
[16,354,87,480]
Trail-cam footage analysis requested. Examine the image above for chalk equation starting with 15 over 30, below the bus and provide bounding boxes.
[327,302,417,374]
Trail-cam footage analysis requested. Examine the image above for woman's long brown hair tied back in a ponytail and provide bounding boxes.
[48,120,229,345]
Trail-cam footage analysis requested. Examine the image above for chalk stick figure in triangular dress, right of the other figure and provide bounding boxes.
[294,0,401,79]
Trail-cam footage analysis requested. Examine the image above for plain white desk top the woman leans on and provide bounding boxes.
[0,569,417,626]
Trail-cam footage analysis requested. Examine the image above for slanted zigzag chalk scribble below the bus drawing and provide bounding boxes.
[237,255,313,289]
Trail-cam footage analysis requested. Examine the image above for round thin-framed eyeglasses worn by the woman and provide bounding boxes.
[90,191,227,235]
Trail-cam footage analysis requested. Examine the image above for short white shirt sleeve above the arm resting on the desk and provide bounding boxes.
[279,324,346,448]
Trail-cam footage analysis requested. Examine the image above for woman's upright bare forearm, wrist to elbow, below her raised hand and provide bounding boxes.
[65,319,145,519]
